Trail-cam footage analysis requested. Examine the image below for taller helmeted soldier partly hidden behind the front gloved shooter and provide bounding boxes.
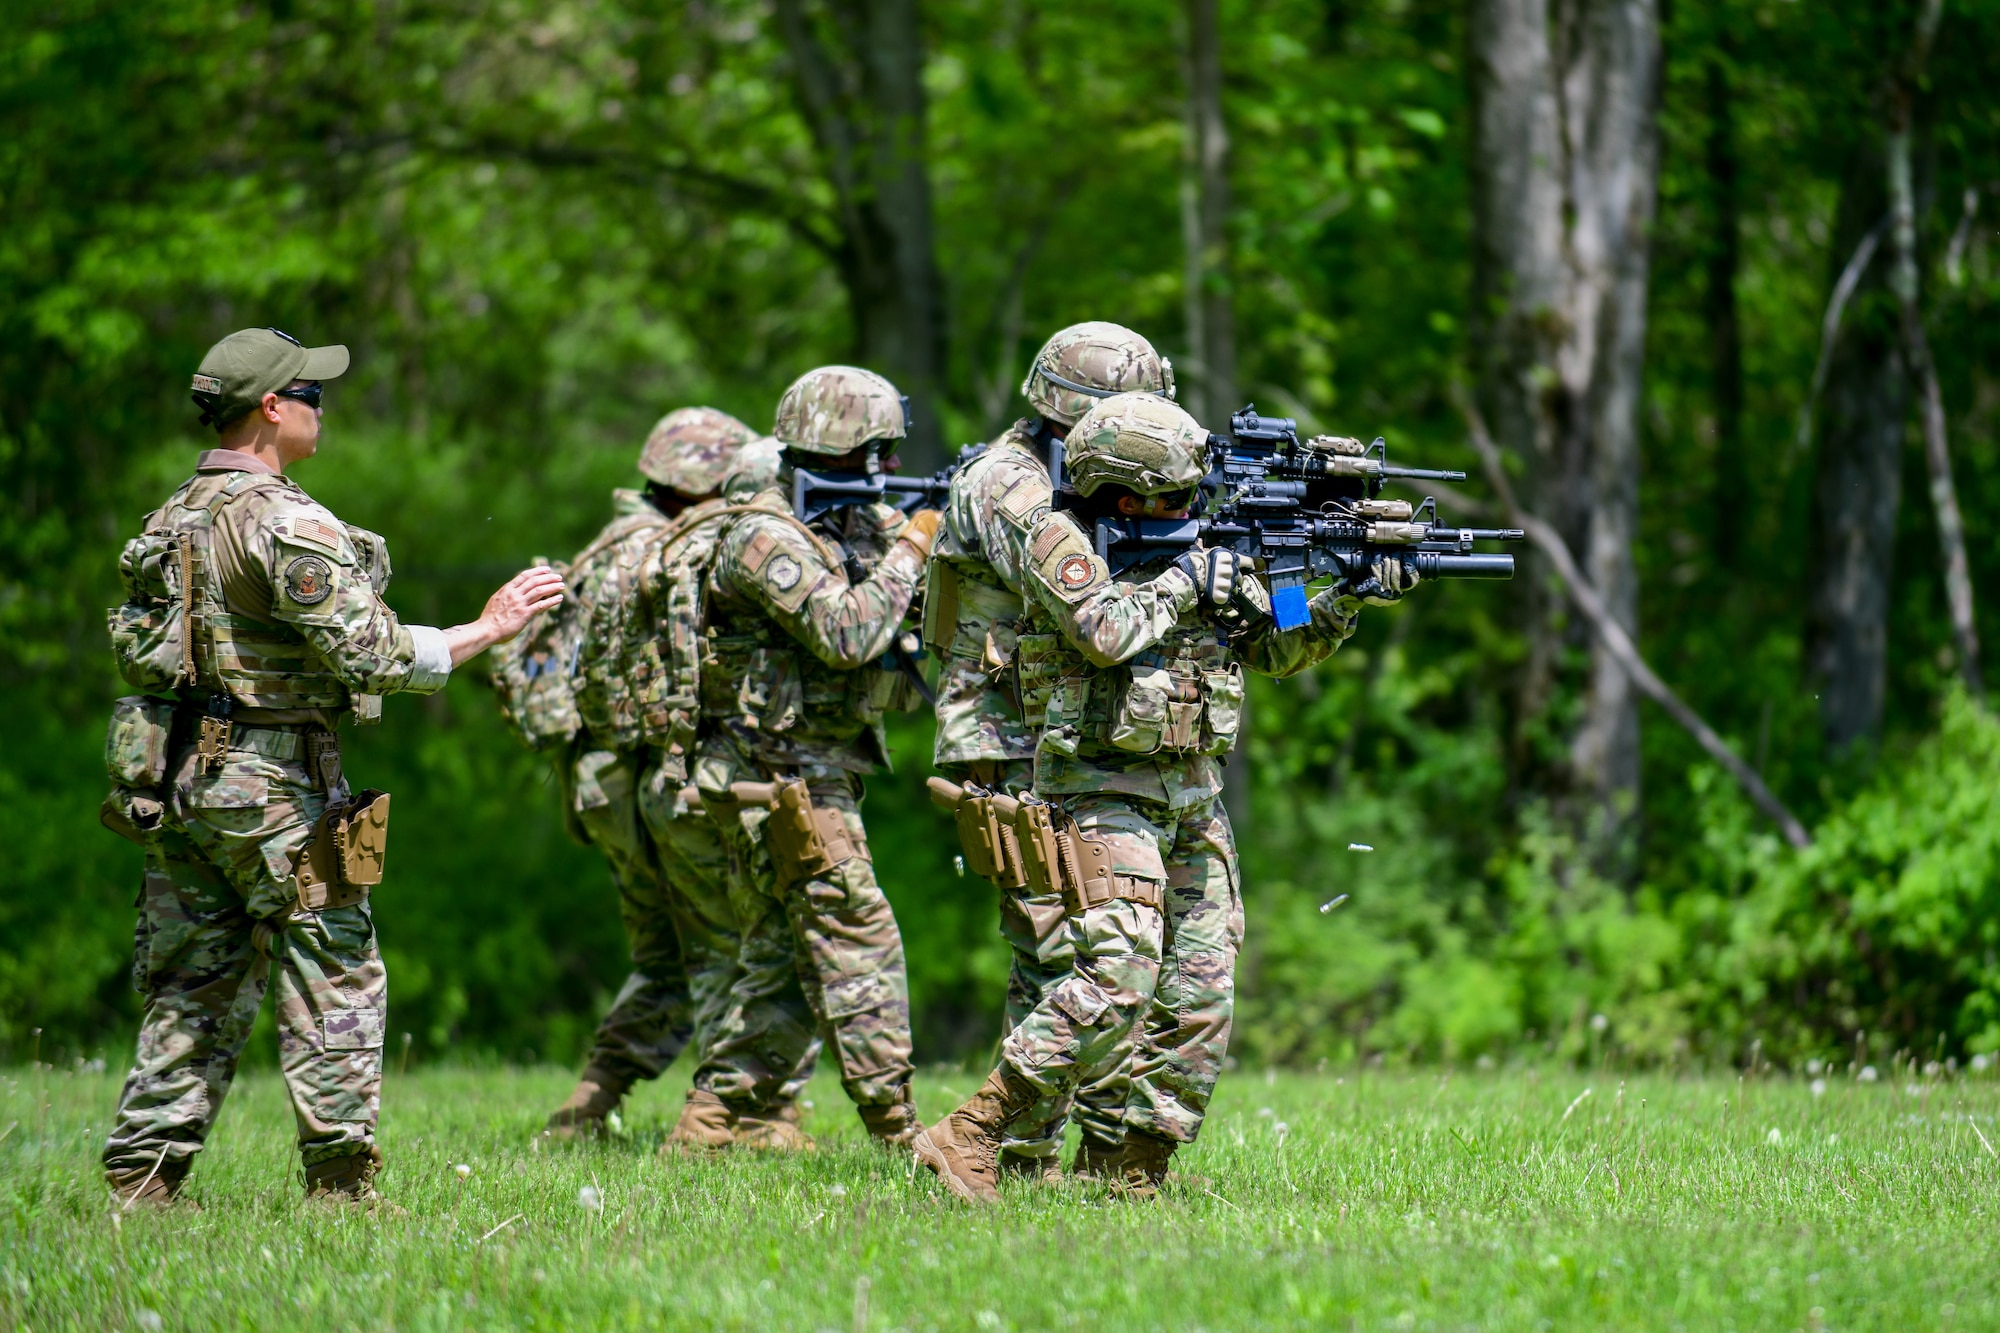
[924,322,1174,1179]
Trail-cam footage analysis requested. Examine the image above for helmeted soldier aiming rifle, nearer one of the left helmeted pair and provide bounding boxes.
[674,366,938,1147]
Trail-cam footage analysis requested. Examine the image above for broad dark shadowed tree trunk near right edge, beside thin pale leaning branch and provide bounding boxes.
[1810,144,1910,753]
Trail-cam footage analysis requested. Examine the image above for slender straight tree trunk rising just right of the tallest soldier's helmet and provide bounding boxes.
[1180,0,1242,420]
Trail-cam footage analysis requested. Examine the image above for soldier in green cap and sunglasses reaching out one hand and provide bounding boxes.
[104,328,562,1205]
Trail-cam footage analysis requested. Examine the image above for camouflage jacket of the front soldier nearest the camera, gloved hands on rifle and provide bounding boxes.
[1016,512,1354,809]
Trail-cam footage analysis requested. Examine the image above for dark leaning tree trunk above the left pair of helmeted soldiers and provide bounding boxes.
[776,0,944,468]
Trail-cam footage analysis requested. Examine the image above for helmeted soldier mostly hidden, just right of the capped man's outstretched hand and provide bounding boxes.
[548,408,778,1139]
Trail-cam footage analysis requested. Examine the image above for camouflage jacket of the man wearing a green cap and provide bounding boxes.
[112,448,452,727]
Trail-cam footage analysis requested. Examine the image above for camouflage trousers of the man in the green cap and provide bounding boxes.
[104,729,388,1171]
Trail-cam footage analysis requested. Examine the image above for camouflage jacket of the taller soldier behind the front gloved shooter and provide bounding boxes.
[924,420,1052,767]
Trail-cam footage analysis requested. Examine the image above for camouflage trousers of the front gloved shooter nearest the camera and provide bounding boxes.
[1000,795,1244,1143]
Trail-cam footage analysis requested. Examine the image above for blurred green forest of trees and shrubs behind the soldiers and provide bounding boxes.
[0,0,2000,1065]
